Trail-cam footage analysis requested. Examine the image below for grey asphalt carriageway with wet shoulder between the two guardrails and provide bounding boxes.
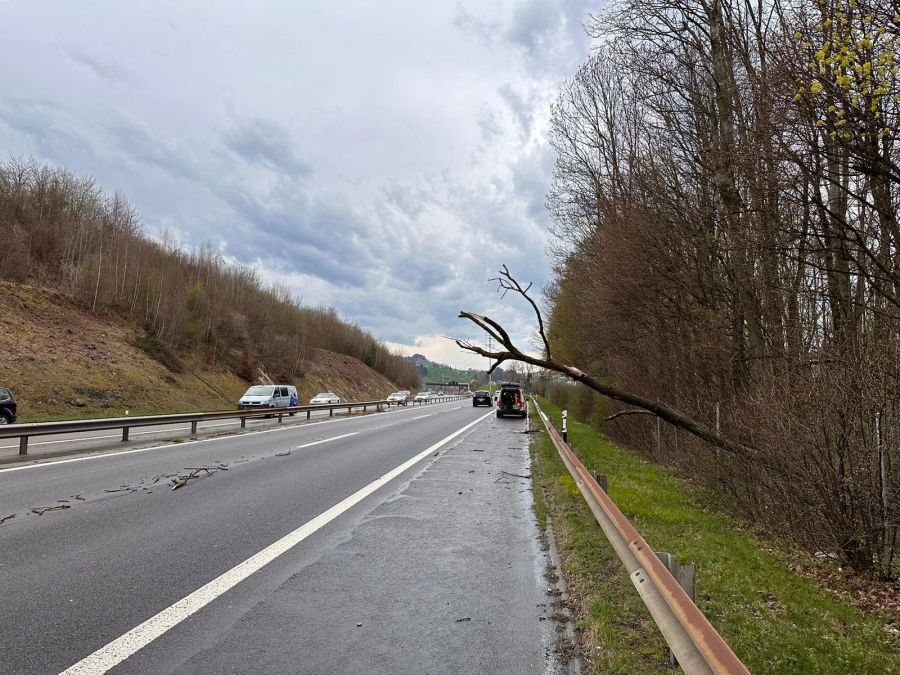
[0,402,575,675]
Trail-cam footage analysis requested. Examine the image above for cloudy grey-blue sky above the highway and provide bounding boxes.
[0,0,598,367]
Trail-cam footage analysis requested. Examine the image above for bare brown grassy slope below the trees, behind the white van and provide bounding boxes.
[0,281,398,422]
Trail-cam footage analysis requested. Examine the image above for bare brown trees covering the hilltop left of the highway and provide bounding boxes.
[0,158,419,388]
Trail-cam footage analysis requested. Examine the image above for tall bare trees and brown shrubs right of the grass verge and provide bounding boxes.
[546,0,900,578]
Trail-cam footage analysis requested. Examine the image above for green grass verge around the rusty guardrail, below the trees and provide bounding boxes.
[531,400,900,673]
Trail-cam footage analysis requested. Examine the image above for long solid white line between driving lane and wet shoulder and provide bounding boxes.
[61,411,493,675]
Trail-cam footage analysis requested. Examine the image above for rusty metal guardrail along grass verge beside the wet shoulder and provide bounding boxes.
[532,399,750,675]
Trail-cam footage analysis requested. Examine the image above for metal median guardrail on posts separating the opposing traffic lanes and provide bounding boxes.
[0,396,465,455]
